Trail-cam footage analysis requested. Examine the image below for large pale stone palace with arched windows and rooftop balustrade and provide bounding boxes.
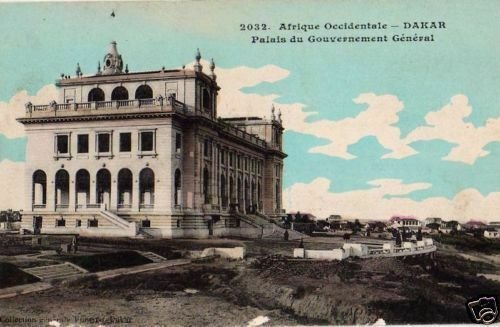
[18,42,286,238]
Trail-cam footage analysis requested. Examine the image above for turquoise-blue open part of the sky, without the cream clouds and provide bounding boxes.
[0,1,500,220]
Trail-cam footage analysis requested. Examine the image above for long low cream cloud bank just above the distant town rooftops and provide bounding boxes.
[283,177,500,222]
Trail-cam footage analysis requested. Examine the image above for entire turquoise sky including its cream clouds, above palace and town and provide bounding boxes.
[0,0,500,221]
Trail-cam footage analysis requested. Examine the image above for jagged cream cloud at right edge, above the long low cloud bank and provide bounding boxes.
[405,95,500,165]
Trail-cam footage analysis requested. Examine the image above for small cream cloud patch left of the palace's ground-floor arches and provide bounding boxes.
[0,160,24,210]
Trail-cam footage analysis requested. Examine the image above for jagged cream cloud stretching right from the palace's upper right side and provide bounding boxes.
[209,62,416,159]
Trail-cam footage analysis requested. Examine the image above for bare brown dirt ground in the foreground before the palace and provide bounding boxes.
[0,238,500,326]
